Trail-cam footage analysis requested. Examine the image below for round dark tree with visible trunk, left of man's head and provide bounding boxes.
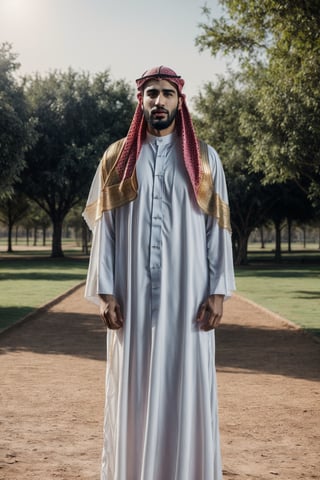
[21,69,134,257]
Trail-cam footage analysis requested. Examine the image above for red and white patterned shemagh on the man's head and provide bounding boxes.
[116,66,201,198]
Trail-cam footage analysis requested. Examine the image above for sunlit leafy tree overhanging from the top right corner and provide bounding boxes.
[196,0,320,210]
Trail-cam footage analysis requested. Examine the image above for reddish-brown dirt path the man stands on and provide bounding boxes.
[0,288,320,480]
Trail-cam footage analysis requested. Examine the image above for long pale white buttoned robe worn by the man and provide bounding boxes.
[86,134,235,480]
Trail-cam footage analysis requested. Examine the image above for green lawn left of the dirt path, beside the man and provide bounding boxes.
[0,252,88,329]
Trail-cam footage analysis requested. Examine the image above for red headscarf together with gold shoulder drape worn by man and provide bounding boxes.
[83,66,231,231]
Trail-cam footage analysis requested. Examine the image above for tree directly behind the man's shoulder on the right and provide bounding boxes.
[194,76,276,265]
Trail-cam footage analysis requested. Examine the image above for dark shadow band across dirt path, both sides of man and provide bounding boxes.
[0,311,320,381]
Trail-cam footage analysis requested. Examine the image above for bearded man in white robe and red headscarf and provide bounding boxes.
[84,66,234,480]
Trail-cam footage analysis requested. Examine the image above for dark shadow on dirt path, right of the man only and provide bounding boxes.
[216,324,320,381]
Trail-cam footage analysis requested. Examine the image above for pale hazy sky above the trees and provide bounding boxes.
[0,0,227,102]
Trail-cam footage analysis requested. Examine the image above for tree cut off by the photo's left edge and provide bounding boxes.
[0,43,33,198]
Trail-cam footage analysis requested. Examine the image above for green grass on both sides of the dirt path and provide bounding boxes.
[0,249,320,335]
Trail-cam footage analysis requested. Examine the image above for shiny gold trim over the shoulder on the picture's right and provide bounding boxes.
[197,140,231,232]
